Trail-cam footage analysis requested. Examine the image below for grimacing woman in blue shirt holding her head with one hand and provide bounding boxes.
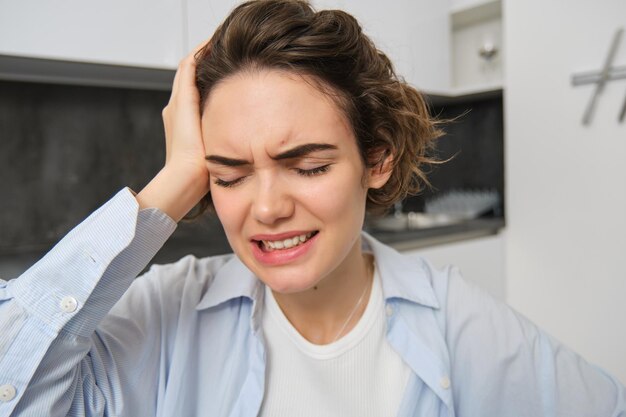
[0,0,626,417]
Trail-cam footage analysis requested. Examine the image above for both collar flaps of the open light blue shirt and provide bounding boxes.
[196,232,439,310]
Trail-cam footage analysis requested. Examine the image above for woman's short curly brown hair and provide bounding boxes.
[196,0,442,213]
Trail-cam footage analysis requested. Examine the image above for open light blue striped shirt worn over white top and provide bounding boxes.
[0,189,626,417]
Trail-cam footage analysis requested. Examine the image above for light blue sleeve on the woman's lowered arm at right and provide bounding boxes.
[445,268,626,417]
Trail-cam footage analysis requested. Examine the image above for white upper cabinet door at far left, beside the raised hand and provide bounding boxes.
[0,0,184,68]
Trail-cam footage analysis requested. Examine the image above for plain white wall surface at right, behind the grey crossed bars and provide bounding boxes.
[503,0,626,382]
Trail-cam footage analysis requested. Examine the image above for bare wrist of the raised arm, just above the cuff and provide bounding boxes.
[135,165,209,222]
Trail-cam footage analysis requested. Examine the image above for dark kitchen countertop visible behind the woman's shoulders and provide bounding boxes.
[0,218,505,280]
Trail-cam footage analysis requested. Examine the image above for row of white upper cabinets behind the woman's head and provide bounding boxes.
[0,0,500,95]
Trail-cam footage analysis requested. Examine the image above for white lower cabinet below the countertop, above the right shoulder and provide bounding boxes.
[405,233,506,300]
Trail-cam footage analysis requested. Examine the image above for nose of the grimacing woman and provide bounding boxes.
[252,173,295,225]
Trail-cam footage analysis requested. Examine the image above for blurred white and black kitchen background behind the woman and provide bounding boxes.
[0,0,626,382]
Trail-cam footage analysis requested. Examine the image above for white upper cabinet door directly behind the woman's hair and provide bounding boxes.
[187,0,450,91]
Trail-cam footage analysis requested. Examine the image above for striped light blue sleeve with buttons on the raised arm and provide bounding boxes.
[0,189,176,417]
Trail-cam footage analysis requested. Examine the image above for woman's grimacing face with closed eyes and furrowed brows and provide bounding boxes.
[202,70,386,293]
